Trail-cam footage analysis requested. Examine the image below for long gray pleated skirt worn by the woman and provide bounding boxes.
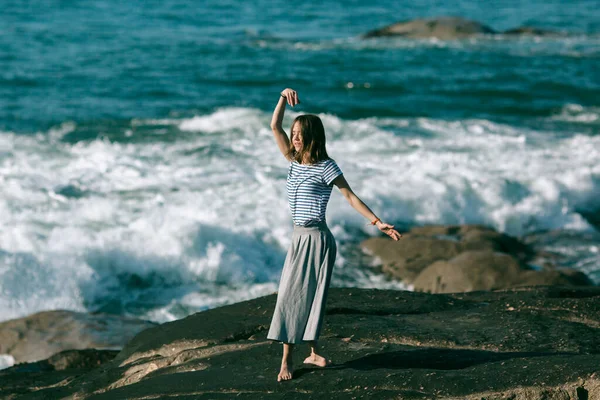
[267,222,337,343]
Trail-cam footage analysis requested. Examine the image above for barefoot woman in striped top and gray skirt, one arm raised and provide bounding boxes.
[267,89,401,381]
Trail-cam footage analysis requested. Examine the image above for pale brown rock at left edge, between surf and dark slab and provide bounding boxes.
[0,310,156,363]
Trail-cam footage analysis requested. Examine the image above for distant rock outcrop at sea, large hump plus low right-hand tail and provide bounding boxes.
[362,17,566,40]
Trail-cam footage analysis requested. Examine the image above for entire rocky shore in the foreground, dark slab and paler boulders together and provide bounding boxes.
[0,225,600,400]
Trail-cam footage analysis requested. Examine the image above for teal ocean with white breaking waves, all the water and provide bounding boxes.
[0,0,600,322]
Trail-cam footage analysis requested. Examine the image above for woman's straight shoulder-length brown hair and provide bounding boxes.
[288,114,329,164]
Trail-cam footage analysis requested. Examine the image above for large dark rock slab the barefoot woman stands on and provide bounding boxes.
[0,287,600,400]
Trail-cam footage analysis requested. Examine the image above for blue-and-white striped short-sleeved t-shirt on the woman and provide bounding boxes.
[286,158,342,226]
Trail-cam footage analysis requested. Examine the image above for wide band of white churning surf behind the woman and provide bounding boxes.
[0,108,600,321]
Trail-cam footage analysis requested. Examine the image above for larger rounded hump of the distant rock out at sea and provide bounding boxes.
[363,17,496,40]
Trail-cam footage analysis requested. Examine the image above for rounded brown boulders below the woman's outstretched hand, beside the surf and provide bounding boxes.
[362,225,592,293]
